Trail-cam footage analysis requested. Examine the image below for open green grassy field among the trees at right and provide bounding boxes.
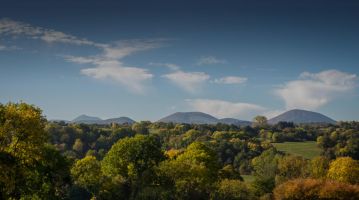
[273,141,321,159]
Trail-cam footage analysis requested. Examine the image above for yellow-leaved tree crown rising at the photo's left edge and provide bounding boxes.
[0,103,47,164]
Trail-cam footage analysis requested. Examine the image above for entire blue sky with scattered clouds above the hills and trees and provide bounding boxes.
[0,0,359,121]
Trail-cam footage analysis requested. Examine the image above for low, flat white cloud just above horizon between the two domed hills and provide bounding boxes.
[186,99,265,119]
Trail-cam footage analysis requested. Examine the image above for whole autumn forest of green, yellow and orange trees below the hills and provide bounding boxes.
[0,102,359,200]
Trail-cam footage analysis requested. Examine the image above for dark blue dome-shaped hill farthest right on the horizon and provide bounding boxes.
[268,109,336,124]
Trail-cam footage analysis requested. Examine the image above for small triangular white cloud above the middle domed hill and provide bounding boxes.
[162,70,210,93]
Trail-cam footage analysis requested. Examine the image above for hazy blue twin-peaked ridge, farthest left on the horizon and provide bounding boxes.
[70,115,135,124]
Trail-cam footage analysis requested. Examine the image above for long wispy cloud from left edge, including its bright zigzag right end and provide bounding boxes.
[0,18,165,93]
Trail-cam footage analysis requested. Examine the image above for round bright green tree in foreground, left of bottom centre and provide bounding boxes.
[102,135,165,198]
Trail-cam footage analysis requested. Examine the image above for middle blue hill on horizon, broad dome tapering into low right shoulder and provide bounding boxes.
[158,112,251,126]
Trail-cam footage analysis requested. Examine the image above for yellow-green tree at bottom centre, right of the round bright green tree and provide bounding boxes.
[159,142,219,199]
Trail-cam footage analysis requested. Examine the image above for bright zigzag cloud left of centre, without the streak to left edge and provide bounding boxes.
[65,40,164,93]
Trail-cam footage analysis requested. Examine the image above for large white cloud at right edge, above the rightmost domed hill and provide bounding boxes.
[275,70,357,110]
